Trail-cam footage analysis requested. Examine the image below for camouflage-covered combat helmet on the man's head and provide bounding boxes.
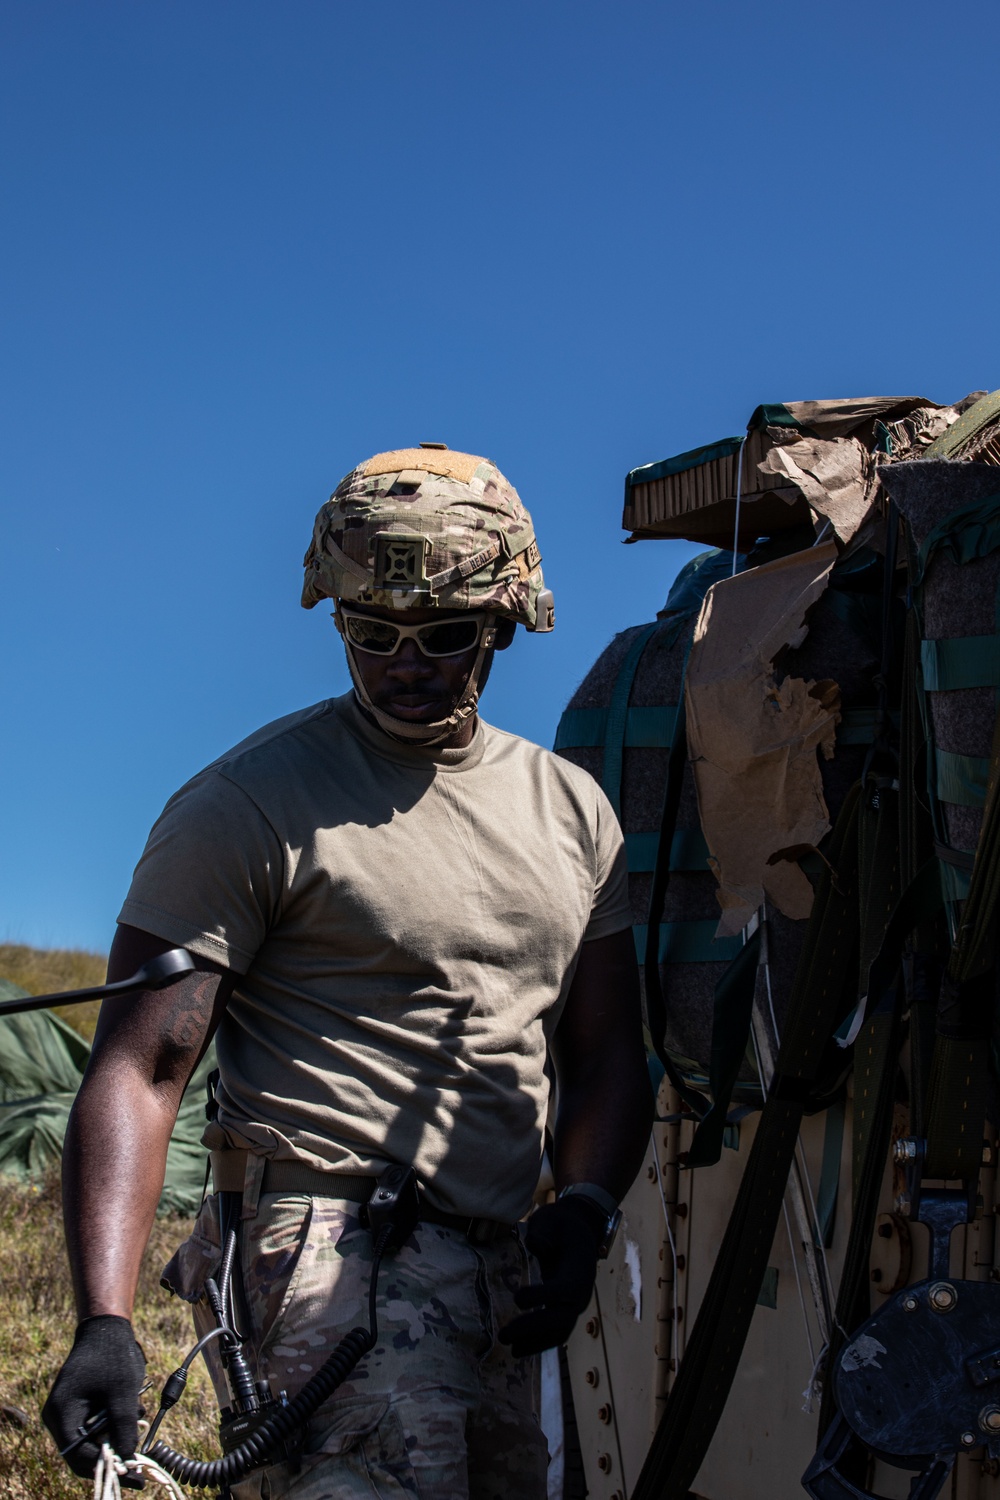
[301,447,552,630]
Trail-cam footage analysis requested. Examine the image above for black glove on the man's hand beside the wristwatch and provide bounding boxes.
[499,1197,606,1359]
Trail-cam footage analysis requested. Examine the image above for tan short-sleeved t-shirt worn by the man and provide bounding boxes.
[118,695,631,1220]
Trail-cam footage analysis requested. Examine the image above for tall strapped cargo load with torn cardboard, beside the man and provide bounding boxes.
[556,392,1000,1500]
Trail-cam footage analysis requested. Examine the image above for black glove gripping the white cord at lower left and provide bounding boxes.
[42,1314,145,1479]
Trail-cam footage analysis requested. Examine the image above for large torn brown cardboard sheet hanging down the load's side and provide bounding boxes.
[685,542,840,938]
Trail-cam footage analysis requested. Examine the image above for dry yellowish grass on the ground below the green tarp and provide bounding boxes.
[0,1176,219,1500]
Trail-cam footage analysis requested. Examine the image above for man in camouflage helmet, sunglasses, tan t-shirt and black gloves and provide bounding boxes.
[45,444,651,1500]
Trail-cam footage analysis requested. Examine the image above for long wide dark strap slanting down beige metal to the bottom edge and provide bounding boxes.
[631,788,858,1500]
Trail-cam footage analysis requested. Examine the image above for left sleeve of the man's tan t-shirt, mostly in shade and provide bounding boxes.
[118,771,285,974]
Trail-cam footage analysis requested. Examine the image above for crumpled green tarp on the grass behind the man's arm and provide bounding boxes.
[0,980,216,1214]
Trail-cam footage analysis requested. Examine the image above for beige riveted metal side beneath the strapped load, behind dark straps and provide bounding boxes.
[568,1097,1000,1500]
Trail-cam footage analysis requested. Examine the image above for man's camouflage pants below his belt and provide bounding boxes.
[165,1194,547,1500]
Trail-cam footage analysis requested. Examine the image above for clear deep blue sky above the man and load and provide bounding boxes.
[0,0,1000,948]
